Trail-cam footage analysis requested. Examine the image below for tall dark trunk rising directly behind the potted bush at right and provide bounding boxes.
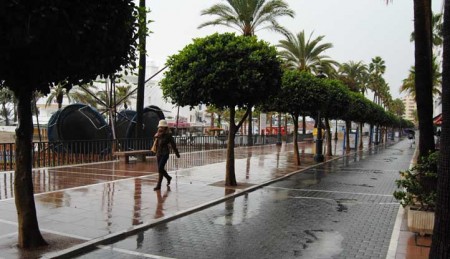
[414,0,435,157]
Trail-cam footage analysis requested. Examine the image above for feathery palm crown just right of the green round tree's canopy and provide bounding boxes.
[278,31,339,77]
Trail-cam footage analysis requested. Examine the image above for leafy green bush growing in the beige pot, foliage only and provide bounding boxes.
[394,152,439,211]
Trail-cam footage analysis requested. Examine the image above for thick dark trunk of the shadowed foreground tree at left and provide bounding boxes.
[14,91,47,248]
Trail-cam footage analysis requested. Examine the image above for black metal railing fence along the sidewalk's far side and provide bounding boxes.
[0,135,306,171]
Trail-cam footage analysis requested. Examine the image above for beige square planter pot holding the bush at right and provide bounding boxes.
[408,206,434,236]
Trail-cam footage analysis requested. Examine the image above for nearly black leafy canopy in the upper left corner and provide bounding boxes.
[0,0,136,94]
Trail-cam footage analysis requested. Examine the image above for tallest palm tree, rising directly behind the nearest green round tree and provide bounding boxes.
[198,0,295,145]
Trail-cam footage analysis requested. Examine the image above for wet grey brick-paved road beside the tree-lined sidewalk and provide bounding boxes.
[70,141,414,258]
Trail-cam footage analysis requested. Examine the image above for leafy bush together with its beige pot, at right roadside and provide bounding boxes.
[394,152,439,235]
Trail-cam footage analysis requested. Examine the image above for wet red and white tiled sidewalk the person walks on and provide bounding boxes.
[0,142,428,258]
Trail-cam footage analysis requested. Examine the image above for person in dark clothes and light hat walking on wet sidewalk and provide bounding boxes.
[153,120,180,191]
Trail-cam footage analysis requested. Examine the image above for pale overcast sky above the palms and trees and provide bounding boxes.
[147,0,442,98]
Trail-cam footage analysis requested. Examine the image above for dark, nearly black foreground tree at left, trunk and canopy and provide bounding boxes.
[0,0,137,248]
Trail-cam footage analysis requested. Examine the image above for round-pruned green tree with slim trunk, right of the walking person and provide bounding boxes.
[161,33,281,186]
